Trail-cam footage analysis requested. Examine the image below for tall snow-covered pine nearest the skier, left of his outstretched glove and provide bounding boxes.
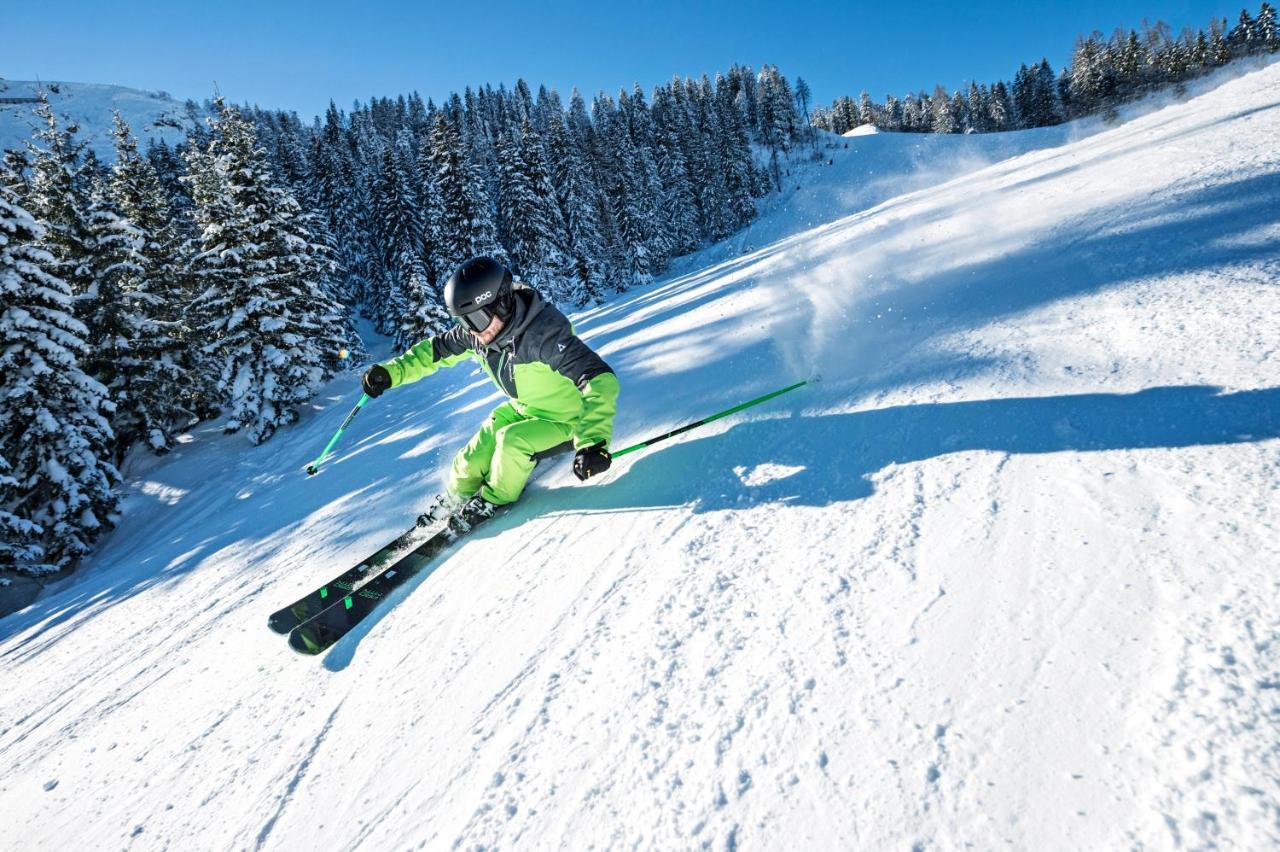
[183,99,351,444]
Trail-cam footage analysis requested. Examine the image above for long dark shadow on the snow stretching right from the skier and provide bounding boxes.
[532,385,1280,522]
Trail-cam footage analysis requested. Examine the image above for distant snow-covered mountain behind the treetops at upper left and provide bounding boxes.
[0,78,192,161]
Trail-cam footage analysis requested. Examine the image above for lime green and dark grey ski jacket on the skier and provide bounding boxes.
[383,281,618,449]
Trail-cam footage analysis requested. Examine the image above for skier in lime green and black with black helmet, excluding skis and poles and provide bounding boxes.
[361,257,618,527]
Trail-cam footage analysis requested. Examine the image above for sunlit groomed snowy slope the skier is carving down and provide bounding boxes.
[0,64,1280,849]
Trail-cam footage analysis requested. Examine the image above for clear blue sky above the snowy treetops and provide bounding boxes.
[0,0,1260,119]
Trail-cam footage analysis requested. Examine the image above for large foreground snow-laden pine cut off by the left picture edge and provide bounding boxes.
[0,187,120,574]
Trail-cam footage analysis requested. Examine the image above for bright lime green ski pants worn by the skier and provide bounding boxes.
[448,403,573,505]
